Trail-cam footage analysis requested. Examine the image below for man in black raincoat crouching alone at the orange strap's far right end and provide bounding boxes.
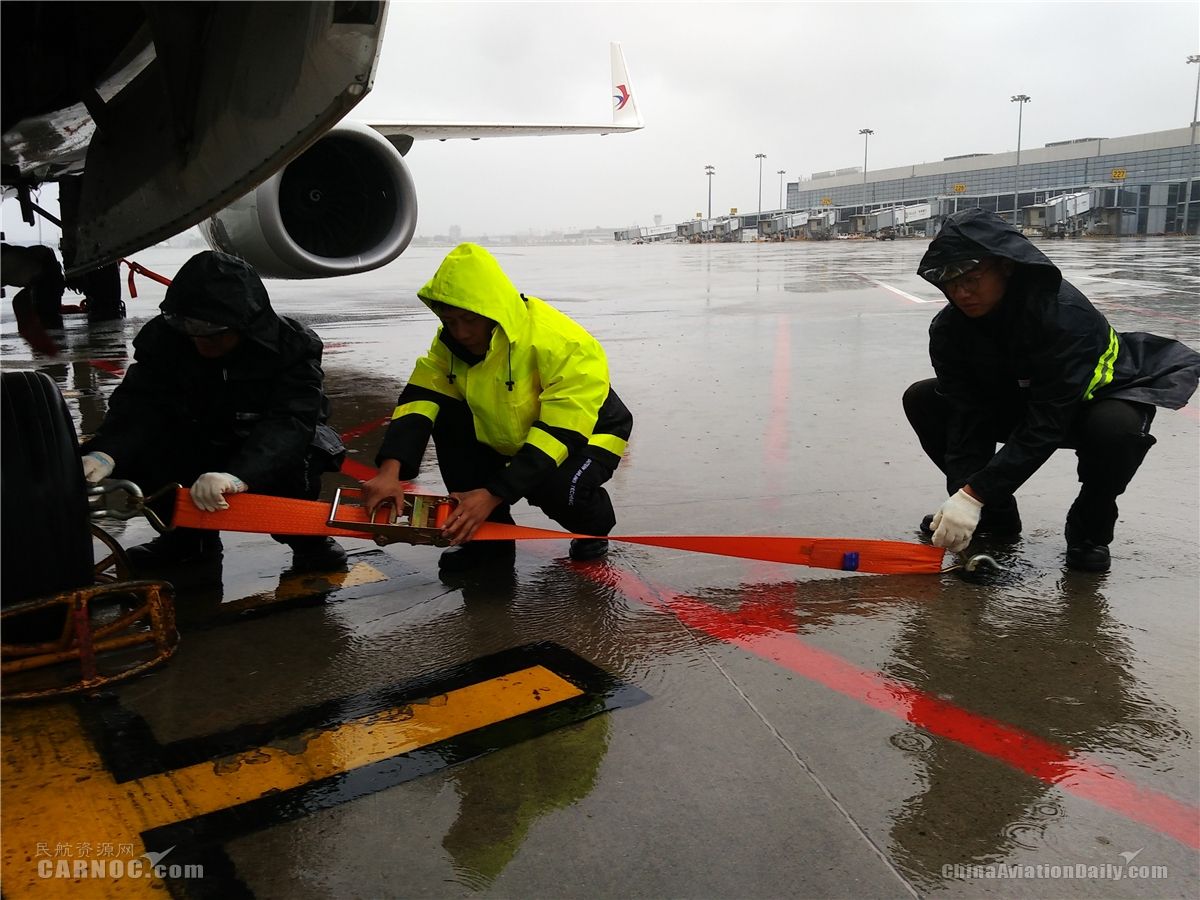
[904,209,1200,571]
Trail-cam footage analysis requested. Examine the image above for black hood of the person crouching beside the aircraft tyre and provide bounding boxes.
[158,250,278,349]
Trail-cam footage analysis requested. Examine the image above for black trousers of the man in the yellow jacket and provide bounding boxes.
[433,403,617,535]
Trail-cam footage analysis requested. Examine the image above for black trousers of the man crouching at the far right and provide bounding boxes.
[904,378,1156,544]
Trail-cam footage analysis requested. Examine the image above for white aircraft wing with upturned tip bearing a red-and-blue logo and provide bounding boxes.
[367,43,644,152]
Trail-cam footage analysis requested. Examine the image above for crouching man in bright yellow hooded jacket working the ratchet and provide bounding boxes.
[362,244,634,571]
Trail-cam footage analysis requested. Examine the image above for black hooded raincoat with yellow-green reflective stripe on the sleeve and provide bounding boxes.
[918,209,1200,502]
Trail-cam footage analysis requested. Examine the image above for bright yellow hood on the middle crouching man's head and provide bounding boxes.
[416,244,528,341]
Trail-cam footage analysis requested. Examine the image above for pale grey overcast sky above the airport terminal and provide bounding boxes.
[5,0,1200,236]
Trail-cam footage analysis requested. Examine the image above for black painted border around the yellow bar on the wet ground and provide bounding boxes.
[79,642,648,900]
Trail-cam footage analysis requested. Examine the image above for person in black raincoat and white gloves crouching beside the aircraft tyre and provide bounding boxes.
[83,251,346,571]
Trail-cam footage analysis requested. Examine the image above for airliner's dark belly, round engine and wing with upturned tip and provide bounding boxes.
[0,21,643,278]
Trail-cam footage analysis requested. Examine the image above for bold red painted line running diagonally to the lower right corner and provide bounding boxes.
[572,564,1200,848]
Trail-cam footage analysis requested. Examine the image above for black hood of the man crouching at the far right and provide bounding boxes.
[917,206,1062,290]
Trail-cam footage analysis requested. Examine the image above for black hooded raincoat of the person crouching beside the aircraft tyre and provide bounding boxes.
[83,251,344,492]
